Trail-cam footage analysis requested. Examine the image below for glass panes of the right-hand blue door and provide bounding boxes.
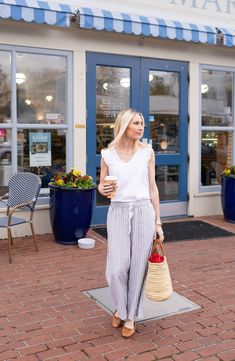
[149,70,180,201]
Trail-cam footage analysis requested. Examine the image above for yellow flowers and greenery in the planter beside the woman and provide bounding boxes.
[49,168,95,189]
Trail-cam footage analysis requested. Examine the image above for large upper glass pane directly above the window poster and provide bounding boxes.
[16,53,67,124]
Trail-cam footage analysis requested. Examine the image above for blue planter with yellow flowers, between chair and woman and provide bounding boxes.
[49,168,96,244]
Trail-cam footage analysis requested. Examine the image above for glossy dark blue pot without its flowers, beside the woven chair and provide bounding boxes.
[49,185,95,245]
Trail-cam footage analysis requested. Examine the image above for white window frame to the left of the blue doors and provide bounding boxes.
[0,45,74,208]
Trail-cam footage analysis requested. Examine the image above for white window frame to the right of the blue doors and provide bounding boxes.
[198,64,235,193]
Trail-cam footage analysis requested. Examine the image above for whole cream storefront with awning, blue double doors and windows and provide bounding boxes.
[0,0,235,233]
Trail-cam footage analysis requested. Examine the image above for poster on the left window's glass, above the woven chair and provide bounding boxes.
[29,132,51,167]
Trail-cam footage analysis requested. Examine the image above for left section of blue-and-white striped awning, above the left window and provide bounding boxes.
[0,0,74,27]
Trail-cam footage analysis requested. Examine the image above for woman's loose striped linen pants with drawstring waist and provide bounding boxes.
[106,200,155,320]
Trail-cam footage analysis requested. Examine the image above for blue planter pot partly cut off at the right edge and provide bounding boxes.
[221,176,235,223]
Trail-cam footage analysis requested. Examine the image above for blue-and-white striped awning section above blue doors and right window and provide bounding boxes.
[79,7,235,46]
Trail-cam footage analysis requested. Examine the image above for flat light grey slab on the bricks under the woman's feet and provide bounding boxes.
[84,287,201,321]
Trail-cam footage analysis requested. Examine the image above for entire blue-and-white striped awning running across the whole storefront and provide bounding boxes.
[0,0,235,47]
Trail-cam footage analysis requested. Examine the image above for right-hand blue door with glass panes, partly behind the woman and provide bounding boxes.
[141,59,188,216]
